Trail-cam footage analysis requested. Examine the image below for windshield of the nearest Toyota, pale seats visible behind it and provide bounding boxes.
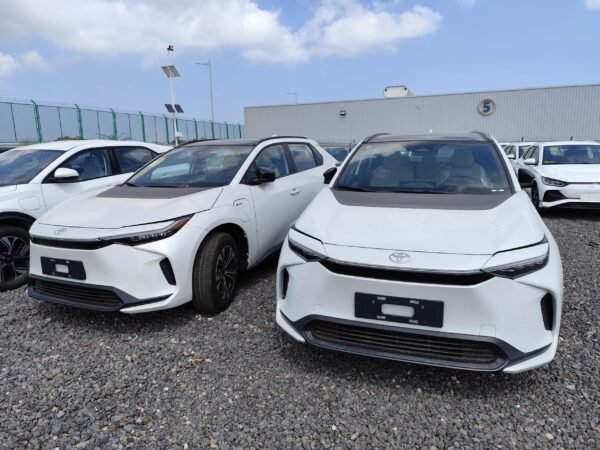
[335,141,511,194]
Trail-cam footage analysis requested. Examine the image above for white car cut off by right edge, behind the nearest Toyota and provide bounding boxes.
[517,141,600,208]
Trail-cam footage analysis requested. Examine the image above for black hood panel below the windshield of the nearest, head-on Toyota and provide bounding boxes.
[332,189,513,211]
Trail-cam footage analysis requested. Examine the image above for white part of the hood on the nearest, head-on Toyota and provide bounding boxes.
[296,189,545,255]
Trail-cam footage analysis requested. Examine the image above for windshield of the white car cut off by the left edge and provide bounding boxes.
[0,149,64,186]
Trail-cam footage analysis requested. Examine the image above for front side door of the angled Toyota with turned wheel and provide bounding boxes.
[242,144,300,260]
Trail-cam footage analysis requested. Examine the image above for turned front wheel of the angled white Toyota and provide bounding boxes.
[192,232,240,314]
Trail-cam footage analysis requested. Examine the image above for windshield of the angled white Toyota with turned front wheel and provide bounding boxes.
[126,144,254,188]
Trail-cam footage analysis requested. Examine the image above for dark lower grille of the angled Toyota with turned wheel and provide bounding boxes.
[31,279,123,311]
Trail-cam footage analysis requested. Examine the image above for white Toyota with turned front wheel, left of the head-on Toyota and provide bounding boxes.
[28,137,336,313]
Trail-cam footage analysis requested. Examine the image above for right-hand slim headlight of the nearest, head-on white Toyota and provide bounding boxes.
[481,242,550,278]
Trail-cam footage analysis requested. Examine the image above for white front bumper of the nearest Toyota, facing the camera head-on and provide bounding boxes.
[277,241,562,372]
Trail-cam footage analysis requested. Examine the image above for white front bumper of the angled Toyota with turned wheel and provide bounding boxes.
[29,223,203,313]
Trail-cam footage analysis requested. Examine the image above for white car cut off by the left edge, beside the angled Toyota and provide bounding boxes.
[0,140,170,291]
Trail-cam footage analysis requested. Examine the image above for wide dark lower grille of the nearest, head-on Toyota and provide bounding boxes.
[305,320,507,370]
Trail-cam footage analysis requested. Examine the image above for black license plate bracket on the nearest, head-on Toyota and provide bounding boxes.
[354,292,444,328]
